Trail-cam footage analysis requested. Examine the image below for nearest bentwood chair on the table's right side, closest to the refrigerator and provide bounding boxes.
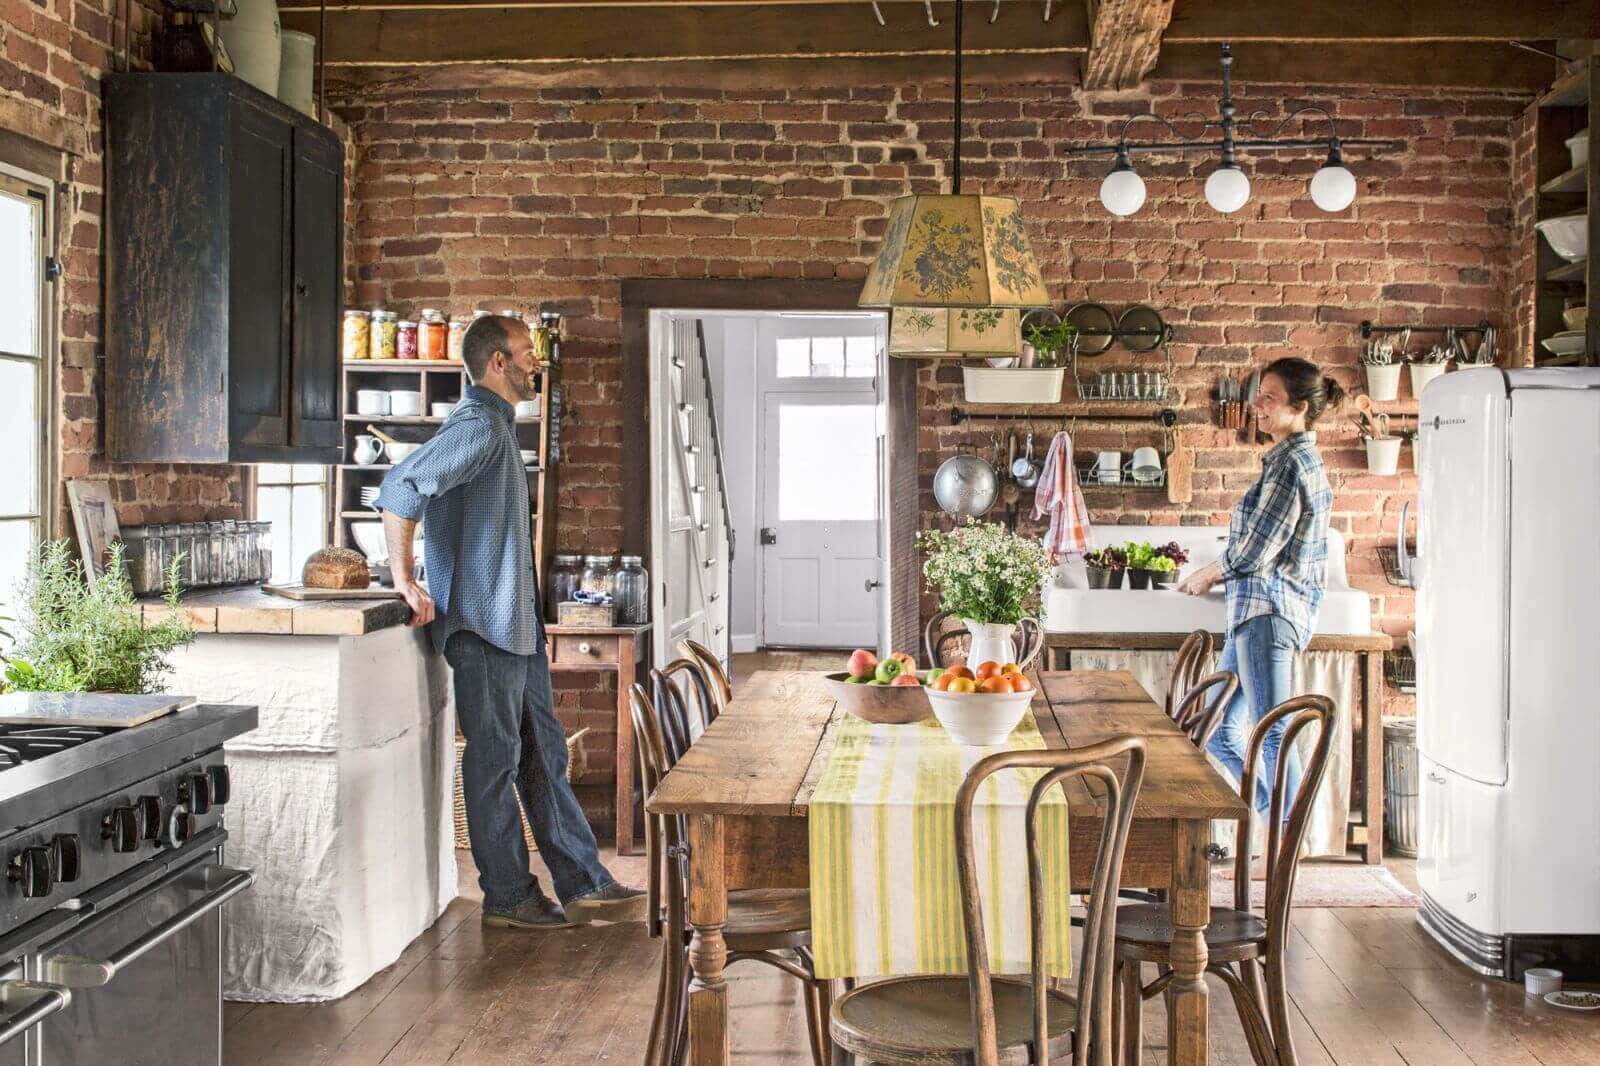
[1115,696,1334,1066]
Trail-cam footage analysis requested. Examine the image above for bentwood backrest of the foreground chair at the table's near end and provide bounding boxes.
[955,736,1144,1066]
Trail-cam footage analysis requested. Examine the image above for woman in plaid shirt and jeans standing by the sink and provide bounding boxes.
[1178,359,1344,813]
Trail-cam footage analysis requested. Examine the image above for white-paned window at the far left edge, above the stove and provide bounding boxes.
[0,168,54,615]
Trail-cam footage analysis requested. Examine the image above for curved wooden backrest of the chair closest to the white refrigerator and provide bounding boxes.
[1234,695,1334,928]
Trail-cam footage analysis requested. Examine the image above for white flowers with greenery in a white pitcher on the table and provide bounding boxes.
[917,522,1054,664]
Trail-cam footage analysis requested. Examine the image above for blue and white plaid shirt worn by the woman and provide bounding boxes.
[1221,434,1333,650]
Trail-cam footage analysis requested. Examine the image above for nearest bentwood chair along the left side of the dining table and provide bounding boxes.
[629,663,832,1066]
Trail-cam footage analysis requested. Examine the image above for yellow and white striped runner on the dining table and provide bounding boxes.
[810,712,1072,978]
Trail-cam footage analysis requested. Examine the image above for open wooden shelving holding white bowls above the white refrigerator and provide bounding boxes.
[1531,59,1600,367]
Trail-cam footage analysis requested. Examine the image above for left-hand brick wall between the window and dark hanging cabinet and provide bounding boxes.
[0,0,243,536]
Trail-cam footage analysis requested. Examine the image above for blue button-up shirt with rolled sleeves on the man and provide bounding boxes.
[378,386,544,655]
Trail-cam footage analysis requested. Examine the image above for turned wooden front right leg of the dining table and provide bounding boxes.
[1166,821,1203,1066]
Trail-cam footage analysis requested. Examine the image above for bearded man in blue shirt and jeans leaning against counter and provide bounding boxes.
[378,315,645,928]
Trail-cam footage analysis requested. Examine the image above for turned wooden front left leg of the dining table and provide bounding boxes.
[688,815,728,1066]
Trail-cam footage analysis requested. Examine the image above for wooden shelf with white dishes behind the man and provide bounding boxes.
[333,314,560,589]
